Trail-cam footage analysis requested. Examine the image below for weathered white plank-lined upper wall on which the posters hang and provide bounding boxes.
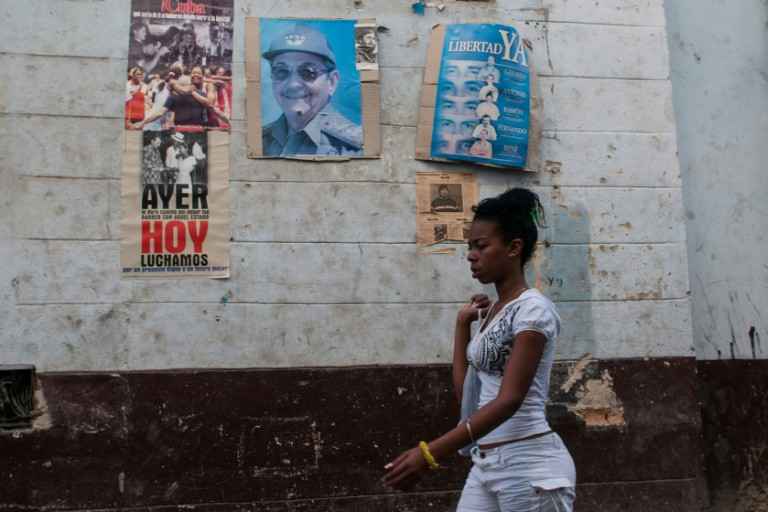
[0,0,692,370]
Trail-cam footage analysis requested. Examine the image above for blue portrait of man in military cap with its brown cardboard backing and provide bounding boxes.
[246,18,381,160]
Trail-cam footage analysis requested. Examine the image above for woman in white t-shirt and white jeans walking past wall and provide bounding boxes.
[384,188,576,512]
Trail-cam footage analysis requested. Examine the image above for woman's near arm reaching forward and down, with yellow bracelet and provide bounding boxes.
[384,331,547,487]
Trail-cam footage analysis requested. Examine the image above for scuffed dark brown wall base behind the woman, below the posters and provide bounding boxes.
[0,358,702,512]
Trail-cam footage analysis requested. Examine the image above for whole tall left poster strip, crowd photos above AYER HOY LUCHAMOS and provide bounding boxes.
[120,0,234,278]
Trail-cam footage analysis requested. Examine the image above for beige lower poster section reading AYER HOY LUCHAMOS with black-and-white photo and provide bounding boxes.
[120,130,229,278]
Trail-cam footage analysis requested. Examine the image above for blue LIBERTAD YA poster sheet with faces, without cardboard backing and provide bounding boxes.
[431,24,530,168]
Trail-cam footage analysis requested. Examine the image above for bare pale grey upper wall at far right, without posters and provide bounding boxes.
[667,0,768,359]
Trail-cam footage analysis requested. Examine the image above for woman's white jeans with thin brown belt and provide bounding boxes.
[456,433,576,512]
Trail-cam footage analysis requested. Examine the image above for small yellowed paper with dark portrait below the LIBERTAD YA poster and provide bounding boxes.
[416,172,477,248]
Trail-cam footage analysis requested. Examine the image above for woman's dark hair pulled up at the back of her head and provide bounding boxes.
[472,188,546,266]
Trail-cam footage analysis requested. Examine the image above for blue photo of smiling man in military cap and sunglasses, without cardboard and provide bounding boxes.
[255,18,364,157]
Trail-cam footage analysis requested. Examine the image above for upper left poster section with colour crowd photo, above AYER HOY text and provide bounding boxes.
[125,0,232,131]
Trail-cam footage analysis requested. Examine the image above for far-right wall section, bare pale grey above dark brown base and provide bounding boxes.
[666,0,768,512]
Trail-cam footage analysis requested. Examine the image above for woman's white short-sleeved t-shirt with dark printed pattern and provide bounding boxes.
[467,289,560,444]
